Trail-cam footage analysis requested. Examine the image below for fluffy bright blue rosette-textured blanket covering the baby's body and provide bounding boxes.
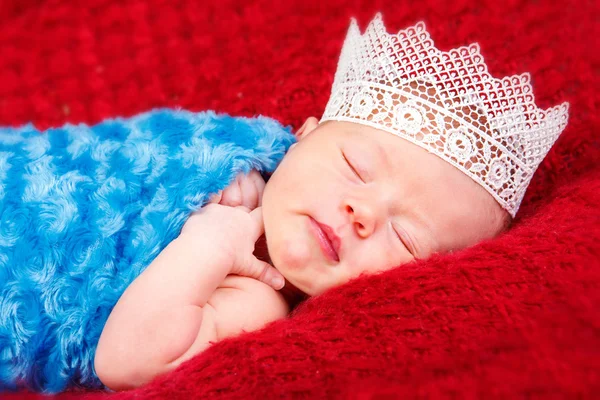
[0,110,294,392]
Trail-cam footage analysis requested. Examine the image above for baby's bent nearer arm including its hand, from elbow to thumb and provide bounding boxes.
[95,198,280,390]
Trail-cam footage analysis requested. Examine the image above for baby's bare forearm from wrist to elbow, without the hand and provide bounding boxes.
[94,235,229,390]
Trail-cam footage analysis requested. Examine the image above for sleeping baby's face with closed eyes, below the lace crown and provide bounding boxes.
[262,118,509,295]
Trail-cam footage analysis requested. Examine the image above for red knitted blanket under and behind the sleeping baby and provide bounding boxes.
[0,0,600,399]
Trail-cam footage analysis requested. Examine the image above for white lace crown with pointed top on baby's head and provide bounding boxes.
[320,13,569,217]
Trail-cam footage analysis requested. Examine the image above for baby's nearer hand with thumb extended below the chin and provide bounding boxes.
[180,204,285,290]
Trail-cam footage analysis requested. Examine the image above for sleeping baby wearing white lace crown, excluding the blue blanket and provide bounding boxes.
[95,15,568,390]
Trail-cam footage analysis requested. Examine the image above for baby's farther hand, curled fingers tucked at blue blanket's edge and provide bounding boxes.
[210,170,265,210]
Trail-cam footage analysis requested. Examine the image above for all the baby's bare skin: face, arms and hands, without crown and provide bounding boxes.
[95,117,510,390]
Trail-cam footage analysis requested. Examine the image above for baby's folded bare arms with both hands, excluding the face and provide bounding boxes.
[94,172,289,390]
